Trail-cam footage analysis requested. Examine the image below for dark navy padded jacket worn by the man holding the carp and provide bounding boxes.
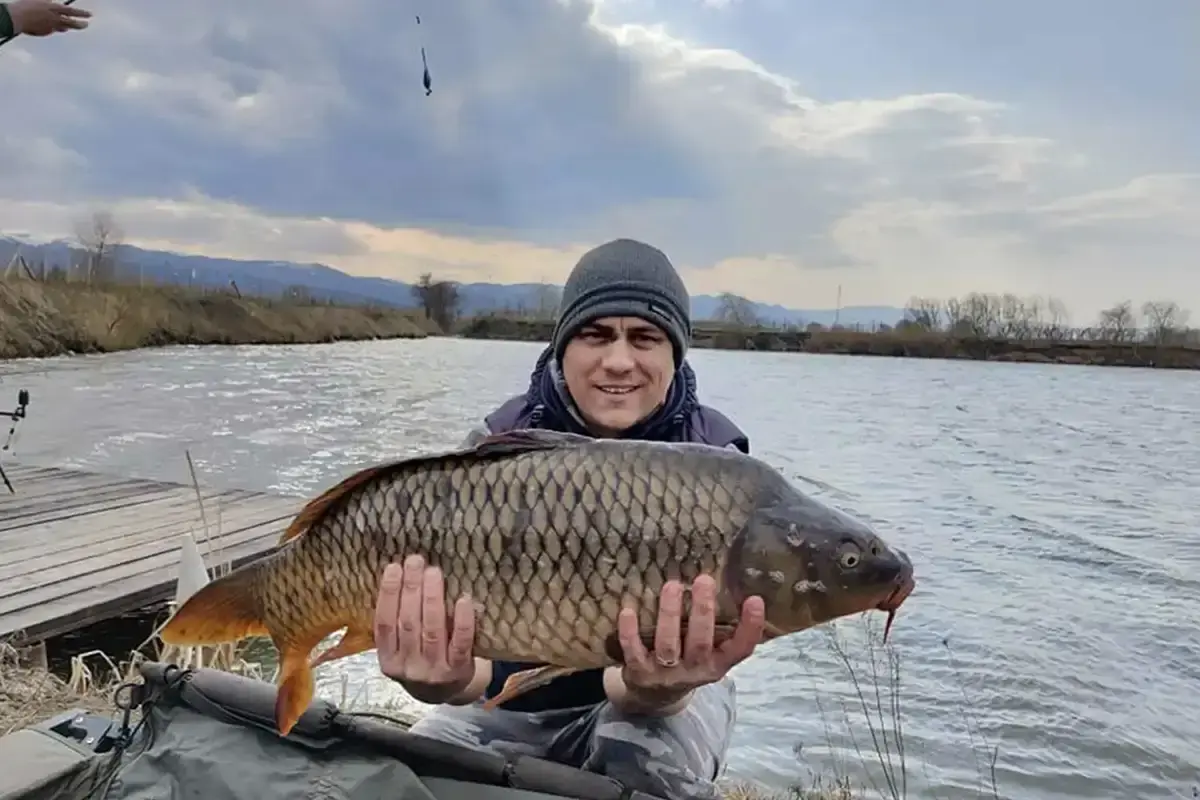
[467,348,750,711]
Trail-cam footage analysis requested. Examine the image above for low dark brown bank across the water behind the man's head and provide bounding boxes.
[457,314,1200,369]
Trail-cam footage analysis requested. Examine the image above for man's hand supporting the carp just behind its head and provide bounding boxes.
[605,575,766,715]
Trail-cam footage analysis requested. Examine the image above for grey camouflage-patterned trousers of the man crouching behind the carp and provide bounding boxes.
[412,678,737,800]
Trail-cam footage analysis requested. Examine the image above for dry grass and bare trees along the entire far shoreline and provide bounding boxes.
[0,244,1200,369]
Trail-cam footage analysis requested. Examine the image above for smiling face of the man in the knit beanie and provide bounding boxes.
[563,317,674,437]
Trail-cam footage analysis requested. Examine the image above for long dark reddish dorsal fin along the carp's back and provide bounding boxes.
[273,428,594,545]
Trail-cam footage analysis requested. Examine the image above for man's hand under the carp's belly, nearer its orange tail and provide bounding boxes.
[374,555,491,704]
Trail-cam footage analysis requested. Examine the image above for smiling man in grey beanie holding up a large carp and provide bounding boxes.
[376,239,763,799]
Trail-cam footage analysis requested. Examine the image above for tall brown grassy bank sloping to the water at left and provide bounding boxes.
[0,279,442,359]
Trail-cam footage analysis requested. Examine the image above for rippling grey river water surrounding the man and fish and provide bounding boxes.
[0,338,1200,800]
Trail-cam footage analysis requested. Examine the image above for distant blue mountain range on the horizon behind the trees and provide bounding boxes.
[0,236,904,326]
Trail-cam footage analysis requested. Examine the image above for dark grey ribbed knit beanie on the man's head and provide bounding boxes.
[552,239,691,367]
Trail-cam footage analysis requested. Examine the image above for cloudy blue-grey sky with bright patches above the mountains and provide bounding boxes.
[0,0,1200,324]
